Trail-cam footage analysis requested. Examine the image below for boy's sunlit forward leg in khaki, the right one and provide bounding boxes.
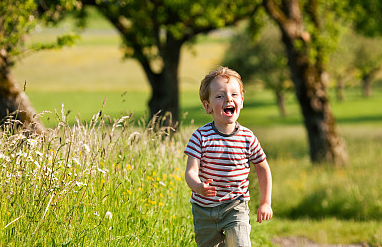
[223,201,251,247]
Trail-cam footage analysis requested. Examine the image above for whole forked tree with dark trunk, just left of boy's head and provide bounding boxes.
[82,0,259,126]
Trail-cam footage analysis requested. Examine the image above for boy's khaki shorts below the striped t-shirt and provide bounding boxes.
[192,200,251,247]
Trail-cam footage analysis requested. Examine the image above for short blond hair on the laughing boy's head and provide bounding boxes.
[199,66,244,102]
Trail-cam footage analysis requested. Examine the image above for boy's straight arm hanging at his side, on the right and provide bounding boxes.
[255,160,273,223]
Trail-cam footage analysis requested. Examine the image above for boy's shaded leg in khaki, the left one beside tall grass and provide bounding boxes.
[192,203,225,247]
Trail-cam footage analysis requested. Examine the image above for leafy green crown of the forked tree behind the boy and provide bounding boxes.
[85,0,262,63]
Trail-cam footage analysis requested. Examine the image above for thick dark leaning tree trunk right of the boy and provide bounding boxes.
[264,0,347,165]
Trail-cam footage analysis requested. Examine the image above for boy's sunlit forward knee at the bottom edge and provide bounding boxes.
[225,224,251,247]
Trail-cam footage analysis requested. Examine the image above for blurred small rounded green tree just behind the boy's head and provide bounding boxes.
[222,25,292,117]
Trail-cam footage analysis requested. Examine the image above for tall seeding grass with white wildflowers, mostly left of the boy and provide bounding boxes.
[0,107,270,246]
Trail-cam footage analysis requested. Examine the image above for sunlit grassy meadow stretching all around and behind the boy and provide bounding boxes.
[0,7,382,246]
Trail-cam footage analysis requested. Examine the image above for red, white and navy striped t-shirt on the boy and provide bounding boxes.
[184,122,266,207]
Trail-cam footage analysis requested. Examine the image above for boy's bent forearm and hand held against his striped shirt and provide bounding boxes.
[184,156,216,196]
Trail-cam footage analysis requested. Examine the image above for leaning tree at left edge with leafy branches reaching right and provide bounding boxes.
[0,0,75,133]
